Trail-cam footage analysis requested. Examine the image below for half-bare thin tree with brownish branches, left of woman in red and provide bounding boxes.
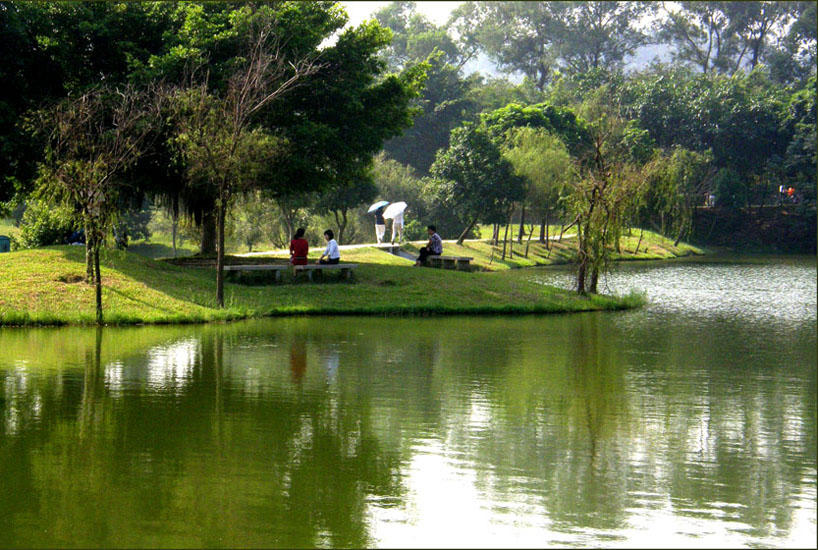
[173,18,320,307]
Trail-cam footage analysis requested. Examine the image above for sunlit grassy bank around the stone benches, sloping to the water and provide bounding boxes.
[0,246,640,325]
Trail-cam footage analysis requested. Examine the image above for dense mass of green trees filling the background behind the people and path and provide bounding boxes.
[0,1,818,302]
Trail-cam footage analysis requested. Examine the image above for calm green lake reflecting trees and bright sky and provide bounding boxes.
[0,257,816,548]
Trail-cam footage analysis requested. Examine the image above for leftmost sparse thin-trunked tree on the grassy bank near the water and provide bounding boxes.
[37,87,161,323]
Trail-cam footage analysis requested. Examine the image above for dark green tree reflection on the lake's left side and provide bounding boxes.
[0,328,399,547]
